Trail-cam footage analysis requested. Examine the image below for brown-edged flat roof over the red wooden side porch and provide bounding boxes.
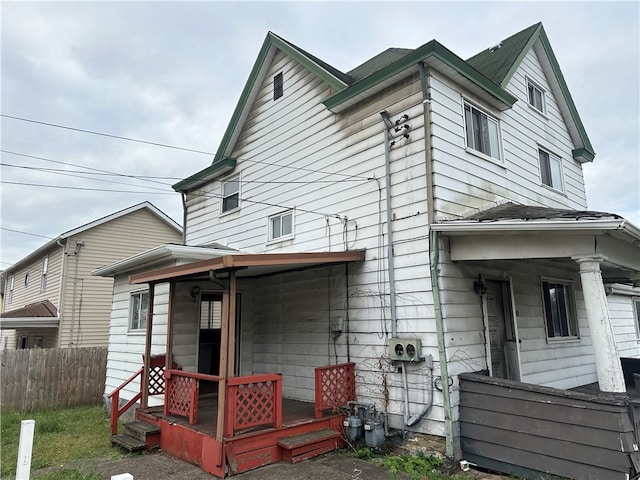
[129,250,366,284]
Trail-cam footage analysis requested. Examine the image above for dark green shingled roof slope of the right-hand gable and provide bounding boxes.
[466,23,542,85]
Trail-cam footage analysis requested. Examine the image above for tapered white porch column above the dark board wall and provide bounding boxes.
[573,255,626,392]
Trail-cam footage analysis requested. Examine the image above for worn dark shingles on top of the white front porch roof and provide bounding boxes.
[464,203,622,222]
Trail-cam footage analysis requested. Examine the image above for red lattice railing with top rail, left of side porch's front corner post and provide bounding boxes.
[164,370,220,425]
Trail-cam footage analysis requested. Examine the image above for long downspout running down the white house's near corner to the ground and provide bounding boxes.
[418,62,454,457]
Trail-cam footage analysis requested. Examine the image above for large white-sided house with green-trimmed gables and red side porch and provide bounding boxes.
[99,24,640,478]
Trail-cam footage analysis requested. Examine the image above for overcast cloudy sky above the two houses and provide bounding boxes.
[0,1,640,269]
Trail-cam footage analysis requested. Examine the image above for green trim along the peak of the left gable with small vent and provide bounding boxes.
[213,32,347,163]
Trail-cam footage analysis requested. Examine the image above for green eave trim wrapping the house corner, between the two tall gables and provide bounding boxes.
[323,40,516,110]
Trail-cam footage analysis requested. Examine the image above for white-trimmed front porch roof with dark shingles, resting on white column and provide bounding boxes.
[431,202,640,283]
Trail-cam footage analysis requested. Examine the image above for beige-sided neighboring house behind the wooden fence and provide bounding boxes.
[0,202,182,348]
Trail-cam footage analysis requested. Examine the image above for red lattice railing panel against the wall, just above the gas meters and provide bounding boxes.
[315,362,356,418]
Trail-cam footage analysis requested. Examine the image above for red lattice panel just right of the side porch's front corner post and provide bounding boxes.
[234,381,276,430]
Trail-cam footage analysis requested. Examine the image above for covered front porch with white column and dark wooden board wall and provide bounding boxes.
[433,204,640,480]
